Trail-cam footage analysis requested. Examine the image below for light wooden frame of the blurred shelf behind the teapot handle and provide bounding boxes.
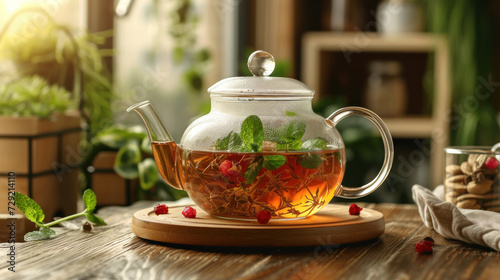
[301,32,451,187]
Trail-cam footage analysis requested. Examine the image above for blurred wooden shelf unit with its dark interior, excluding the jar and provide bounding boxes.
[301,32,451,186]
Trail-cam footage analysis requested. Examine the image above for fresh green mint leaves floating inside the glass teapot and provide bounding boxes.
[215,114,328,184]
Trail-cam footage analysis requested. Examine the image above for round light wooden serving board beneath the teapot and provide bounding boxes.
[132,204,385,247]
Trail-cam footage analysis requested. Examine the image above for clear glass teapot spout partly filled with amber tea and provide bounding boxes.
[127,100,184,190]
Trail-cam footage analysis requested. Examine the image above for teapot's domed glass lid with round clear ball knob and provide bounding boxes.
[208,51,314,98]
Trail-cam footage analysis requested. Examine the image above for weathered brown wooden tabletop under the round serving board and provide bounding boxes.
[0,202,500,279]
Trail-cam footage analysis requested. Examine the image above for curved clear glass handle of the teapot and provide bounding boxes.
[327,107,394,199]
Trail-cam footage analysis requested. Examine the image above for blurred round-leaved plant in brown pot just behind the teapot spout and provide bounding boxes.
[82,126,186,206]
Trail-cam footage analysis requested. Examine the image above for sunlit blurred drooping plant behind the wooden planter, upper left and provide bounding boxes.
[0,8,114,139]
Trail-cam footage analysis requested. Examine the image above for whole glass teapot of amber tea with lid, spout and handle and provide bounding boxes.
[128,51,394,219]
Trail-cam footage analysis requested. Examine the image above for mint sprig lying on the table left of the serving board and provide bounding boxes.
[14,189,106,241]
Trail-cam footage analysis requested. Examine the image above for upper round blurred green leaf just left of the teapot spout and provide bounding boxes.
[113,141,142,179]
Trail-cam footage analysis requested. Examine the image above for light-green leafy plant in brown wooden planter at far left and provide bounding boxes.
[0,76,81,221]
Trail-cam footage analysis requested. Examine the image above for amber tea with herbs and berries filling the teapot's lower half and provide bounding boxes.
[153,142,345,219]
